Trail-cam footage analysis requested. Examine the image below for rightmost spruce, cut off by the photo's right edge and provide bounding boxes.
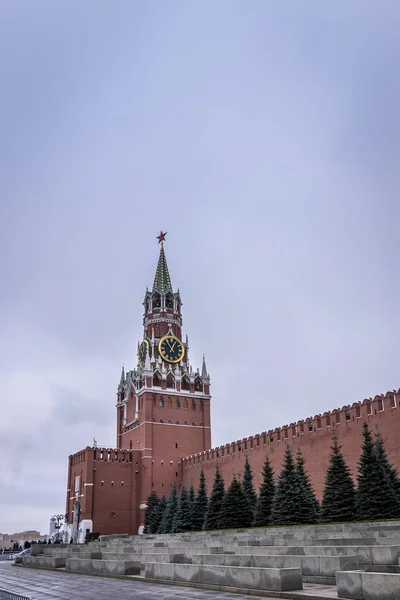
[375,434,400,519]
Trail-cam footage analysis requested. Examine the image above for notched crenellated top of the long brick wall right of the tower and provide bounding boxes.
[181,389,400,468]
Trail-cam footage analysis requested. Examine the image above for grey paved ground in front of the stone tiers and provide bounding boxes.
[0,562,337,600]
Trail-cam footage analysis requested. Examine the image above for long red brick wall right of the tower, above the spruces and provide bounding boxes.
[181,392,400,498]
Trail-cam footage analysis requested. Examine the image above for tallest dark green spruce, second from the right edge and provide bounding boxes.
[356,423,390,521]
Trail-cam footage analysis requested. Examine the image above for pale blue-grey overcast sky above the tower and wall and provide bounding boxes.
[0,0,400,533]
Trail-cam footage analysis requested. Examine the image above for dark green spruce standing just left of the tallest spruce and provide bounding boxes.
[321,438,356,523]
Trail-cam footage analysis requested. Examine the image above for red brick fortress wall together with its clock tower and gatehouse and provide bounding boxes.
[66,232,400,541]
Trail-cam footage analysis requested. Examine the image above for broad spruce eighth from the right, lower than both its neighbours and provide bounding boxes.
[218,477,253,529]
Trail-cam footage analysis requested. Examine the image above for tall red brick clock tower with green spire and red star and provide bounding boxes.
[116,232,211,520]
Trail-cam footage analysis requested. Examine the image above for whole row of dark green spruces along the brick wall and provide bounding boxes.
[144,423,400,533]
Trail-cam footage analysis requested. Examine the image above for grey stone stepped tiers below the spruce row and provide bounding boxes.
[22,521,400,600]
